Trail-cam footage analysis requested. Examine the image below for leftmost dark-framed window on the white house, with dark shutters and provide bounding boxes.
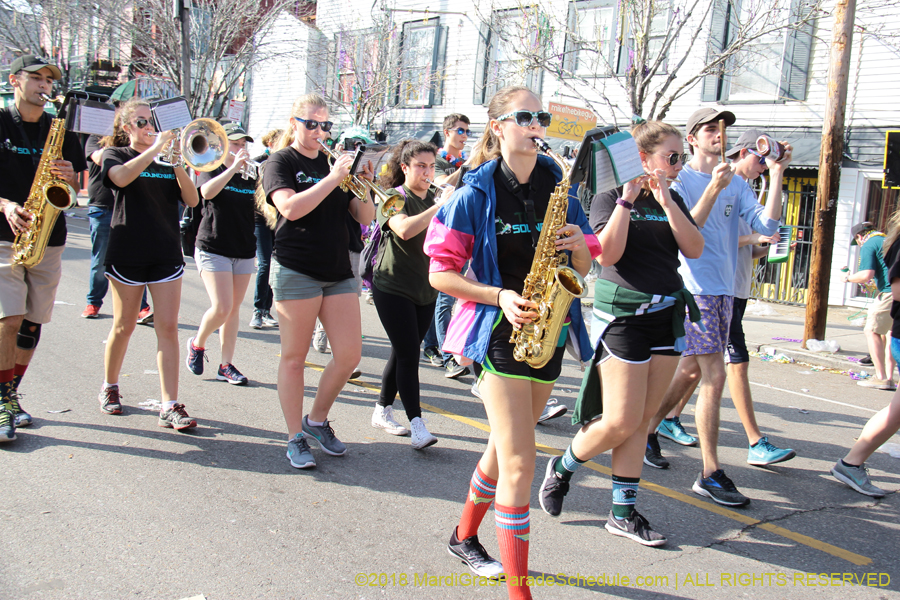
[397,19,447,107]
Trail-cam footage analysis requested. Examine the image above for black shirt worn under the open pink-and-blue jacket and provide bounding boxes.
[494,159,556,293]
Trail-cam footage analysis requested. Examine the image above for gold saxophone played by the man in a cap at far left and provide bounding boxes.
[13,103,77,267]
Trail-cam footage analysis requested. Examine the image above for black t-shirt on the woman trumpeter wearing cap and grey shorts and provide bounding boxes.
[197,165,256,258]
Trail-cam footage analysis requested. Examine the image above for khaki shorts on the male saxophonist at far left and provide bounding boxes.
[0,242,65,325]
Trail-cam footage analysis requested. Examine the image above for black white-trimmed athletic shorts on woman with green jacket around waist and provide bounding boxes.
[597,307,681,364]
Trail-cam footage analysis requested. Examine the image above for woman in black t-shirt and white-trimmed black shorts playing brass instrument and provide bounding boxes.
[100,99,199,430]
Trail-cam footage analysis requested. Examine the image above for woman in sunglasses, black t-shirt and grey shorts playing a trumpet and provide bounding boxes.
[257,94,375,469]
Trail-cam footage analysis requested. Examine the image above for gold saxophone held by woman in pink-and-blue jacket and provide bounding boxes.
[509,138,587,369]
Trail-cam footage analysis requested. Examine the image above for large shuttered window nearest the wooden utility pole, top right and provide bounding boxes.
[701,0,814,102]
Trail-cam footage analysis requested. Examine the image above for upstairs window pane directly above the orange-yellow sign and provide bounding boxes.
[565,0,617,77]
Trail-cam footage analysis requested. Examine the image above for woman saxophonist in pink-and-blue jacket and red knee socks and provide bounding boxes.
[425,87,600,598]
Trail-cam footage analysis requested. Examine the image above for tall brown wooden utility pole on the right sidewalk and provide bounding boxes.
[803,0,856,348]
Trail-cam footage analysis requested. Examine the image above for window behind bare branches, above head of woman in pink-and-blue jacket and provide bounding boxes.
[473,8,550,104]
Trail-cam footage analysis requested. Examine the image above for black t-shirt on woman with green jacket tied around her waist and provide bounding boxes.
[590,188,696,294]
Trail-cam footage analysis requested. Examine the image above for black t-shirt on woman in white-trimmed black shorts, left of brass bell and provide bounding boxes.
[102,147,184,267]
